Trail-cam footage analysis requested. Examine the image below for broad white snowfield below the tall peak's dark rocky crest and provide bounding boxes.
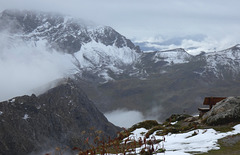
[74,41,139,70]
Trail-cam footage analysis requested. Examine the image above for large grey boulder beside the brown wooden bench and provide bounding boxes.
[203,97,240,125]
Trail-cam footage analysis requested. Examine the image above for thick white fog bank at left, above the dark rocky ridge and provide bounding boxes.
[0,33,75,101]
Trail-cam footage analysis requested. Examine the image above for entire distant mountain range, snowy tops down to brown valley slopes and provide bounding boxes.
[0,10,240,120]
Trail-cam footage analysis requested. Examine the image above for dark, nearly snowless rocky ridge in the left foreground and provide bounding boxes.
[0,80,119,154]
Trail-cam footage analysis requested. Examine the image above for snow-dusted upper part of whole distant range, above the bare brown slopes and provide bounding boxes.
[0,10,240,82]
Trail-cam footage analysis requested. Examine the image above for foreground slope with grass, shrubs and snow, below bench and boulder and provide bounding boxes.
[72,112,240,155]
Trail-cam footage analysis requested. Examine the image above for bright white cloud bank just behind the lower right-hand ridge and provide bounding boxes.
[135,35,240,55]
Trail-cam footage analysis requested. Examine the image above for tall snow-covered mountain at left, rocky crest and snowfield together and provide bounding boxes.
[0,10,141,83]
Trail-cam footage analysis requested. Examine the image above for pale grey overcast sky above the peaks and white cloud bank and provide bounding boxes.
[0,0,240,47]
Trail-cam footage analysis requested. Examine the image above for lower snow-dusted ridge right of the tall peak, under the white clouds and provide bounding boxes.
[137,45,240,79]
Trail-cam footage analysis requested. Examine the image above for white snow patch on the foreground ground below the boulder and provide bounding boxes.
[123,124,240,155]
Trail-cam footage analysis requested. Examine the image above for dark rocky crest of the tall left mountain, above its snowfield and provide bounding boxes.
[0,10,141,53]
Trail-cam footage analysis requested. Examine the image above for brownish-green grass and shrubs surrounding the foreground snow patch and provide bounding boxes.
[71,115,240,155]
